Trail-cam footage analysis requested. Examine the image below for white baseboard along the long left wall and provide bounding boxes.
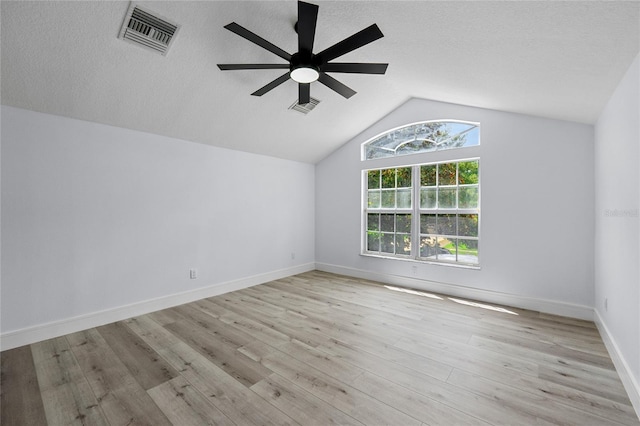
[0,263,315,351]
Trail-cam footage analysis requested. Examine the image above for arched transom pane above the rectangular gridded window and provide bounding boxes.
[362,120,480,160]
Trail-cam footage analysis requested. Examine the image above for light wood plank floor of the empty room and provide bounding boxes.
[1,271,640,426]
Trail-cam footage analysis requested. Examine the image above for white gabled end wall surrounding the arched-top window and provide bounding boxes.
[316,99,594,319]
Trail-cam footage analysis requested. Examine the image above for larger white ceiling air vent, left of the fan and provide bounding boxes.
[119,4,180,56]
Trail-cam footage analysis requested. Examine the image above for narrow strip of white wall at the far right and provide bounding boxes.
[595,55,640,414]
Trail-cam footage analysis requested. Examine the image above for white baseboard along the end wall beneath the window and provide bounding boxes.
[316,263,593,321]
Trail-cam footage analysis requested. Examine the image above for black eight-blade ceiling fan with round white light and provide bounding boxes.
[218,1,389,104]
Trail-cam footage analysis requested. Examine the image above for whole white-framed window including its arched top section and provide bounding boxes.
[362,122,480,266]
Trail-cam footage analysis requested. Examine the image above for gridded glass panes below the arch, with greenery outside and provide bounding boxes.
[367,151,479,257]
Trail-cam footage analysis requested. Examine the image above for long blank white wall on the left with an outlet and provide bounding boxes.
[1,106,315,349]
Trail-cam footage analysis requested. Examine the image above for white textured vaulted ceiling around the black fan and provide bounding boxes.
[1,0,640,163]
